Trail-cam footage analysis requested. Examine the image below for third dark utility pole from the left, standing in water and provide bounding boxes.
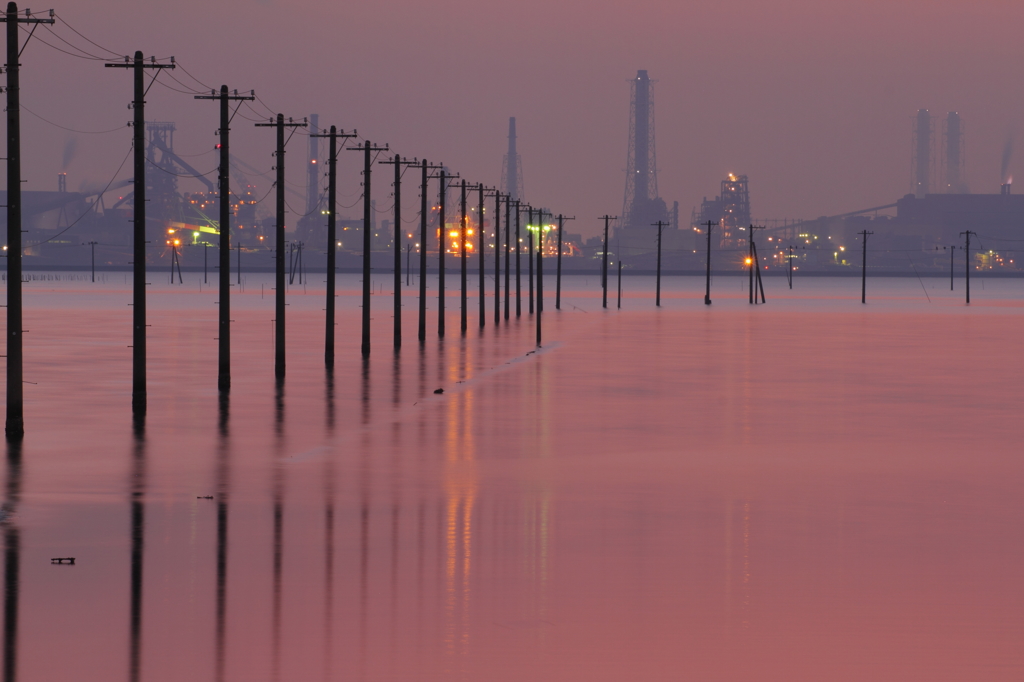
[196,85,256,391]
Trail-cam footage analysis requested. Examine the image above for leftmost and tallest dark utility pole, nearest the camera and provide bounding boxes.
[2,2,53,440]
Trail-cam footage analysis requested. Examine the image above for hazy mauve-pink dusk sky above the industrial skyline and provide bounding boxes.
[14,0,1024,233]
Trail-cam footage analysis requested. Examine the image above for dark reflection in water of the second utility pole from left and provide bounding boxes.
[128,413,145,682]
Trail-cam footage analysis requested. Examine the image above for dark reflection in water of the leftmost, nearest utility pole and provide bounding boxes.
[0,440,22,682]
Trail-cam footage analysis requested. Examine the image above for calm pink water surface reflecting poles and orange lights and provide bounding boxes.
[2,275,1024,681]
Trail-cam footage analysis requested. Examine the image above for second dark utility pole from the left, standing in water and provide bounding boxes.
[106,49,174,415]
